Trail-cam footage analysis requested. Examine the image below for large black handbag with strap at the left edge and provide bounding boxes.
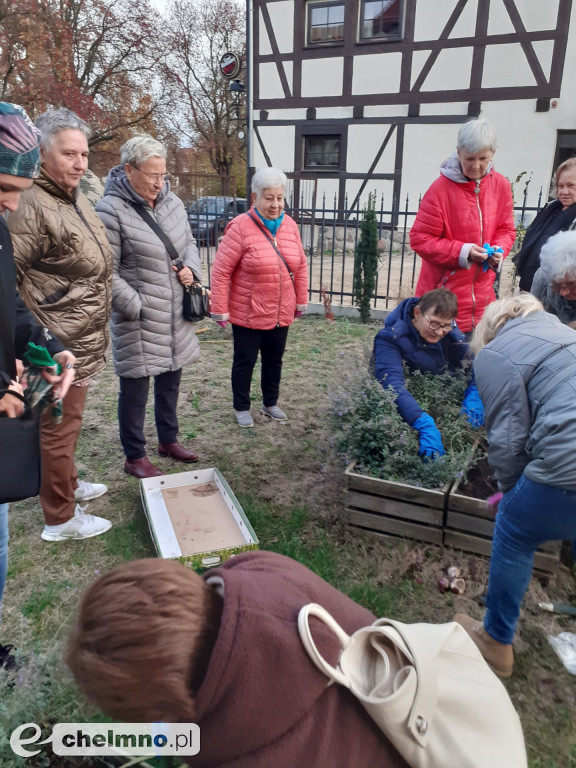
[0,276,41,504]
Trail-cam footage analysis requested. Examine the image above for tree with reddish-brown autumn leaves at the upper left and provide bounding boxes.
[0,0,171,158]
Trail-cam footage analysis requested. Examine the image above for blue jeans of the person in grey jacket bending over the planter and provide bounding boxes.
[484,475,576,644]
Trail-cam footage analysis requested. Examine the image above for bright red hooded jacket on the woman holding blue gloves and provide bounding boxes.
[410,156,516,332]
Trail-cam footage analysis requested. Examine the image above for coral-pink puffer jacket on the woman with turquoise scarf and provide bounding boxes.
[210,208,308,331]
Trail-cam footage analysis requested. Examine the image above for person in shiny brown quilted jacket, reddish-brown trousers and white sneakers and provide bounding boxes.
[8,109,112,541]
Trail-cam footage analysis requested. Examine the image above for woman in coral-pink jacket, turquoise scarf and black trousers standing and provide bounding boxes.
[210,168,308,427]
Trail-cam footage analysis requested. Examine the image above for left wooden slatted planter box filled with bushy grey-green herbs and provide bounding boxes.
[332,361,478,544]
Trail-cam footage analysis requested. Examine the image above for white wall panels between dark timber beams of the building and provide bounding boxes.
[254,0,576,208]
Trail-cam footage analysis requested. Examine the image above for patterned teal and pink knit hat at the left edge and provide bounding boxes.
[0,101,40,179]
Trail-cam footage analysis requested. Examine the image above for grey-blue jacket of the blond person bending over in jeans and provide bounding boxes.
[474,312,576,492]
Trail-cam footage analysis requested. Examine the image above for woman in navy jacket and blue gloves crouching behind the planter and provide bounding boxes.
[374,288,484,459]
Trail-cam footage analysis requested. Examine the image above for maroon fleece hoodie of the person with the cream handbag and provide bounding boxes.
[187,552,407,768]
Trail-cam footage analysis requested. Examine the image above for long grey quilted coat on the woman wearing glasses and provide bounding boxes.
[96,166,201,379]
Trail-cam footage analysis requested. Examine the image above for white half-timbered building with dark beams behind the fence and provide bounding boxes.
[251,0,576,207]
